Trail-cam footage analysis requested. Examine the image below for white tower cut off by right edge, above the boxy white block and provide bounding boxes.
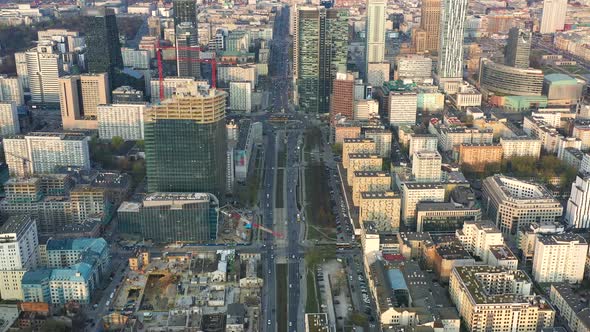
[564,170,590,229]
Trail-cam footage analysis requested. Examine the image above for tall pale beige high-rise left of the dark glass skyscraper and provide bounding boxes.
[25,41,63,104]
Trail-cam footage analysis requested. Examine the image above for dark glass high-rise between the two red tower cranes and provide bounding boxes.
[176,22,201,78]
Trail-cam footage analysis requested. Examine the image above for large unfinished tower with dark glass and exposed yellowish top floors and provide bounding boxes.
[144,82,227,197]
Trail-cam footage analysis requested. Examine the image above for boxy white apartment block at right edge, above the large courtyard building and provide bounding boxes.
[533,233,588,283]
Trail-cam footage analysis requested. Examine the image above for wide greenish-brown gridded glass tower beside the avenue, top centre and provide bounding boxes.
[293,7,348,113]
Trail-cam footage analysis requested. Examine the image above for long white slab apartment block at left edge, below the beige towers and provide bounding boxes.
[4,132,90,177]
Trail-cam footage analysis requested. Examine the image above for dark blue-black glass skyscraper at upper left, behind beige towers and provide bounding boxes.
[84,7,123,74]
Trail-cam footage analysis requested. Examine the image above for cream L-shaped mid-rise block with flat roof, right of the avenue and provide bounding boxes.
[400,182,445,225]
